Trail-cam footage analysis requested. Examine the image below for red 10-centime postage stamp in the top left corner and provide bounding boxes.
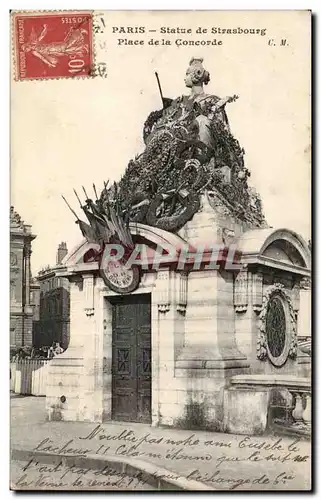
[13,12,93,80]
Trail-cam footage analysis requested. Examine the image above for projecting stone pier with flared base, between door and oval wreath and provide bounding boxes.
[176,270,249,370]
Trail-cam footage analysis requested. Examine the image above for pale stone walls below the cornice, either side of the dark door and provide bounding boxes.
[47,222,308,431]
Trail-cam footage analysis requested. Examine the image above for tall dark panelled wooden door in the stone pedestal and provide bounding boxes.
[112,294,151,423]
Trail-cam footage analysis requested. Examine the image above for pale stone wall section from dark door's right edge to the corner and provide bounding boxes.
[153,270,247,430]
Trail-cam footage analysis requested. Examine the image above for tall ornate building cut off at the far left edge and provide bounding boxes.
[10,207,36,346]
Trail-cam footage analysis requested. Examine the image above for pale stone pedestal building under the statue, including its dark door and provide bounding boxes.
[47,212,310,434]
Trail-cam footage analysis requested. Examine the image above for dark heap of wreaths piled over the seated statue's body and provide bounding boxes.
[119,110,265,232]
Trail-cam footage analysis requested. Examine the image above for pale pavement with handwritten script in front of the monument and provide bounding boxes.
[11,396,311,490]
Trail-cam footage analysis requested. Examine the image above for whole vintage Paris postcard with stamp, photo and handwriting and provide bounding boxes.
[10,9,312,492]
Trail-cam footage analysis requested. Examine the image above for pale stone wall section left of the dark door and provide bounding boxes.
[46,276,102,421]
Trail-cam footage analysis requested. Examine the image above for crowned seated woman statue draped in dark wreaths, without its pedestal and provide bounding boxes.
[105,58,252,231]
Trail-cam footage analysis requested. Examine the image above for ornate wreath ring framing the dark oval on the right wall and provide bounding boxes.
[256,283,297,366]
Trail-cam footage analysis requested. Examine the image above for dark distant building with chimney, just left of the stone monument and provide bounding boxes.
[34,242,70,349]
